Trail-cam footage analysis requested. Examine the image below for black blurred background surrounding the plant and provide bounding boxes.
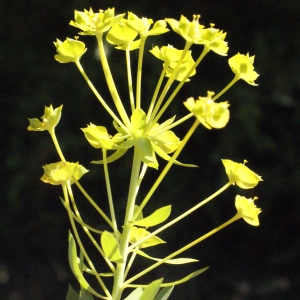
[0,0,300,300]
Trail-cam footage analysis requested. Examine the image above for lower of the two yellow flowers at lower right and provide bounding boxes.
[235,195,261,226]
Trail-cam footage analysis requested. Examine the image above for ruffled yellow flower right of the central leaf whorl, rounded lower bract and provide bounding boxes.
[183,91,229,129]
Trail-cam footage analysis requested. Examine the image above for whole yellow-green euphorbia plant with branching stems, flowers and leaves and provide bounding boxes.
[28,8,262,300]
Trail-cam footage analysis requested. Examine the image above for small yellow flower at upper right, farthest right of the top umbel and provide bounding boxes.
[228,53,259,85]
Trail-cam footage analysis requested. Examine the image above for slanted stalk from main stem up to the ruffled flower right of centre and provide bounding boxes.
[132,119,199,221]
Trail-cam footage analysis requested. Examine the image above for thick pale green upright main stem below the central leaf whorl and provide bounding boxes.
[112,147,141,300]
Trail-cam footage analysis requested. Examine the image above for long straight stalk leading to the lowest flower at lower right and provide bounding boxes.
[124,214,241,288]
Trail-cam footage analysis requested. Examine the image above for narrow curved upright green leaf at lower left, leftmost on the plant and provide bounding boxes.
[68,232,97,294]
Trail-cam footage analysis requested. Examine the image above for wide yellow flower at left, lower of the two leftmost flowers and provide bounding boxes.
[41,161,88,185]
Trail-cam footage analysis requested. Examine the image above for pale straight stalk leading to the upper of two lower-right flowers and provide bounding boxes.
[129,181,232,251]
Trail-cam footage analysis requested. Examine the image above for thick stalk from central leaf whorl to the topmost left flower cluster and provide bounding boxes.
[96,32,130,128]
